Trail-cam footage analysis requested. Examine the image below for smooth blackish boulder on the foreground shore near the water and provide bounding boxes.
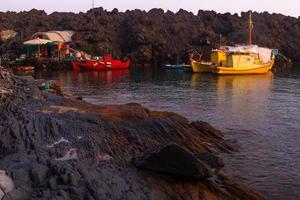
[134,145,212,179]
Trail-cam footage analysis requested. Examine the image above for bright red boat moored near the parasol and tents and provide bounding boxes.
[72,55,130,70]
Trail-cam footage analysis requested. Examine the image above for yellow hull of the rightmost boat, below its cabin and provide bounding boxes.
[213,61,274,74]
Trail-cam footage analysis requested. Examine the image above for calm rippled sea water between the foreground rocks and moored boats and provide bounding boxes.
[24,69,300,200]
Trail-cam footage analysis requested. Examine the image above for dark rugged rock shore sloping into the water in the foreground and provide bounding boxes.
[0,68,263,200]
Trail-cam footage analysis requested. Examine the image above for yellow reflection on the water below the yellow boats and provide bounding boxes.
[191,72,273,128]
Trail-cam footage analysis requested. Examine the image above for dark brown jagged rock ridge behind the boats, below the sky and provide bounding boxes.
[0,8,300,63]
